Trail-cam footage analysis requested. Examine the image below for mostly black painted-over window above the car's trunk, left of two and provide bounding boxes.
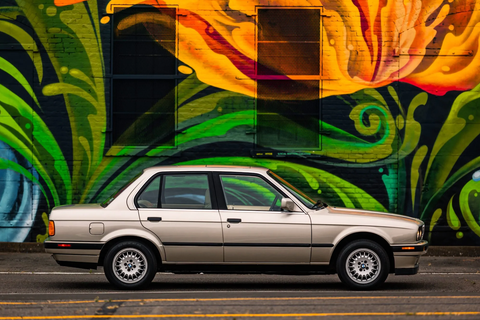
[112,7,177,146]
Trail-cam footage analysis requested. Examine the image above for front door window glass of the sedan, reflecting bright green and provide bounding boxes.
[220,175,282,211]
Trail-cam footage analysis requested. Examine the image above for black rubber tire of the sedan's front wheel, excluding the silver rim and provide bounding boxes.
[336,240,390,290]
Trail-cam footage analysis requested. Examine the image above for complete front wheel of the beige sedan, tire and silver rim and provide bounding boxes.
[336,240,390,290]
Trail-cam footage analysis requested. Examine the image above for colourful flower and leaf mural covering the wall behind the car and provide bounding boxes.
[0,0,480,245]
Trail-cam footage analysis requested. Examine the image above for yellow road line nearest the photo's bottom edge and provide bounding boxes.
[0,311,480,320]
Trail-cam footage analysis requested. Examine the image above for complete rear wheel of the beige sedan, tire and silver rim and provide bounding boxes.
[103,241,157,290]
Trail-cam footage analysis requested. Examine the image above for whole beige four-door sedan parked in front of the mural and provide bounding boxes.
[45,165,428,289]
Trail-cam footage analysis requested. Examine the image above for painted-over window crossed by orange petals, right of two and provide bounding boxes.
[256,9,320,149]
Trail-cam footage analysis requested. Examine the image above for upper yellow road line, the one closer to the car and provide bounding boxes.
[0,295,480,306]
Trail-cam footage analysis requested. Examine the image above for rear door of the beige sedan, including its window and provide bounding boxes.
[135,172,223,263]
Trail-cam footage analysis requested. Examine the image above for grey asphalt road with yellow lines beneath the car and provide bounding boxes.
[0,253,480,320]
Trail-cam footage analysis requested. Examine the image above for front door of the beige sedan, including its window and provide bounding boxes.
[217,174,311,264]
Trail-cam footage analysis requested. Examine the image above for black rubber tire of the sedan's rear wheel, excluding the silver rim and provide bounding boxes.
[103,241,157,290]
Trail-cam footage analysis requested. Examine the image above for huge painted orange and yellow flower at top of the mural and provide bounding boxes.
[107,0,480,99]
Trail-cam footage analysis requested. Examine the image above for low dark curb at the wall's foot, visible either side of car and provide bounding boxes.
[0,242,480,257]
